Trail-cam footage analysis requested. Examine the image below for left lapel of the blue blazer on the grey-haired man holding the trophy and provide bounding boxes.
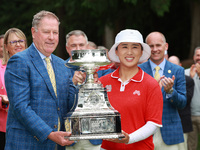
[29,45,56,99]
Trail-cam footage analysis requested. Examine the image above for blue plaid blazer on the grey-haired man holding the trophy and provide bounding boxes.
[5,45,76,150]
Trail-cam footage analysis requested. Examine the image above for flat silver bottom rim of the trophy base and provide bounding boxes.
[65,133,125,141]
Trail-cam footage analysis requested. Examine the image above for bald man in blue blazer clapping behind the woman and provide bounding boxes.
[139,32,187,150]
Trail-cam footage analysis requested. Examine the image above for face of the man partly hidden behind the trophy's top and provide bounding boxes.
[66,35,87,57]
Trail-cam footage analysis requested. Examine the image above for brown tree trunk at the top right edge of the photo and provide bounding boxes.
[190,0,200,58]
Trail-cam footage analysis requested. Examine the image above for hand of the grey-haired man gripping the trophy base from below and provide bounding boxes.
[48,131,74,146]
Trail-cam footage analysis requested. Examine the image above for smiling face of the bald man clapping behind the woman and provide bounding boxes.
[147,33,168,65]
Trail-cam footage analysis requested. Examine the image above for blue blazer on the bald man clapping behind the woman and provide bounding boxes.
[138,61,187,145]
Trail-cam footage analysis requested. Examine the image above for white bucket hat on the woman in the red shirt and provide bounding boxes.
[108,29,151,63]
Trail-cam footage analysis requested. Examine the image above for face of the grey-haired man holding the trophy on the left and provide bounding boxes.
[31,17,59,56]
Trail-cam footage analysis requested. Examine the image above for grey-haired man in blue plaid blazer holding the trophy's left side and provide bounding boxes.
[5,11,82,150]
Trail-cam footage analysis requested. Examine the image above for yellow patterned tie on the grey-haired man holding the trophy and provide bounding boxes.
[45,57,57,96]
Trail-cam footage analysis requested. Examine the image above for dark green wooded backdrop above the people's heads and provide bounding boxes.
[0,0,194,62]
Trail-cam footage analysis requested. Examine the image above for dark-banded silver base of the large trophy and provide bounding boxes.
[65,108,124,141]
